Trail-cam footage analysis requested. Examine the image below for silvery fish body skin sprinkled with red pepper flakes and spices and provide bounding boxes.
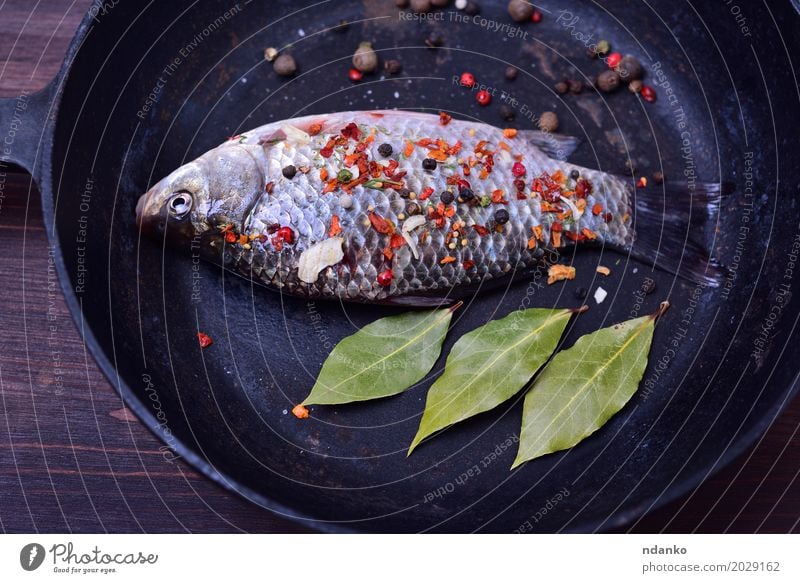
[140,111,634,302]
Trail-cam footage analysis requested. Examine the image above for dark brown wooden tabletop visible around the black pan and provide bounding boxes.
[0,0,800,533]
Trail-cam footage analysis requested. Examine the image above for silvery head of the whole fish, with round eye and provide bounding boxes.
[136,144,265,243]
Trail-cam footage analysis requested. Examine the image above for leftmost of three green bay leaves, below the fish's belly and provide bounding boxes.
[302,302,461,405]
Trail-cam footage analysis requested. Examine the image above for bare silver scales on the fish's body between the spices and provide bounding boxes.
[231,112,632,301]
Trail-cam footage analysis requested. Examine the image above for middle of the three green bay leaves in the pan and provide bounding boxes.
[408,308,575,455]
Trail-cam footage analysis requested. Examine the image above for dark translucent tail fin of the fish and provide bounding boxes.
[628,182,734,287]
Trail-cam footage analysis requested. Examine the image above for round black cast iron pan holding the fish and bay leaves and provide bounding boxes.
[0,0,800,532]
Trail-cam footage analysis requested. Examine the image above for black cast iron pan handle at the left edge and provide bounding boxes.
[0,83,57,178]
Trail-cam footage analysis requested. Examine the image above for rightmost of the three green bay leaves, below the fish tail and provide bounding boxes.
[511,302,669,469]
